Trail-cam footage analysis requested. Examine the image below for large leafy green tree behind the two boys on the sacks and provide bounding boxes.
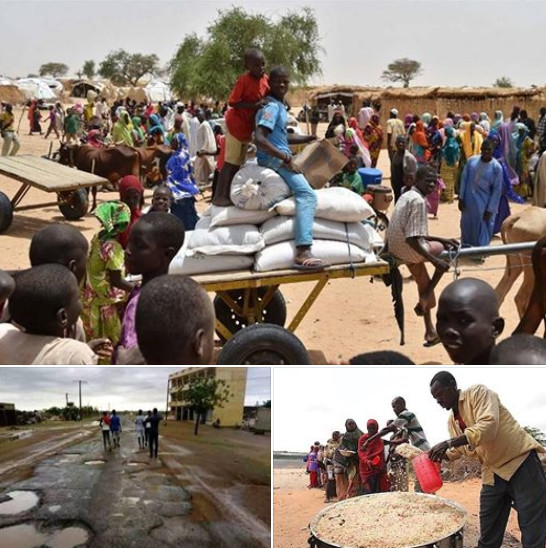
[169,8,322,98]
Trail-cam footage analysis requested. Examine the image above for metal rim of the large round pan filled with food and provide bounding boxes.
[309,493,466,548]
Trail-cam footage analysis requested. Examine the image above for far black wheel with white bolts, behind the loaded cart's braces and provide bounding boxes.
[214,287,286,342]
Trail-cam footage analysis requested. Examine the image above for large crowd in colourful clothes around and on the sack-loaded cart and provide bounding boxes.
[0,45,546,364]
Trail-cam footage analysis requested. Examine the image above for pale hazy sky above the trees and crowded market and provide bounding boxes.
[0,0,546,87]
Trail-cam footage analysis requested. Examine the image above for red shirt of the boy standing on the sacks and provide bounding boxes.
[225,72,269,141]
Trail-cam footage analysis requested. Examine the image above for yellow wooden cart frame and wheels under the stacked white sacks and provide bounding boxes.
[192,260,389,364]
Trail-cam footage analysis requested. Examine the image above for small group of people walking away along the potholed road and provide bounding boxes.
[99,407,163,458]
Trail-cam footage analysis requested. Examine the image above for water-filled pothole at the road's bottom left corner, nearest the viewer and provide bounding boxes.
[0,523,89,548]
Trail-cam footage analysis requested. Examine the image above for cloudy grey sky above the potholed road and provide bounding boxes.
[0,367,271,411]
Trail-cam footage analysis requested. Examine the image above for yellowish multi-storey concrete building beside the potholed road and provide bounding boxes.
[169,367,247,427]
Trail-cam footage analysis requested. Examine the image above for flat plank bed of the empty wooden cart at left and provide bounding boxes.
[0,155,107,192]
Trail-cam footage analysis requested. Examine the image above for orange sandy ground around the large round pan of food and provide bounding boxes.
[273,468,521,548]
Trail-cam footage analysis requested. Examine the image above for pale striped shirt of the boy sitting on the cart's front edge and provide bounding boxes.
[387,187,428,264]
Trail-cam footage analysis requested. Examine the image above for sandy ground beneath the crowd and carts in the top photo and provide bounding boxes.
[0,109,525,364]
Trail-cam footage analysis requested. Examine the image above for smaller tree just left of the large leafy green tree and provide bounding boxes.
[99,49,159,86]
